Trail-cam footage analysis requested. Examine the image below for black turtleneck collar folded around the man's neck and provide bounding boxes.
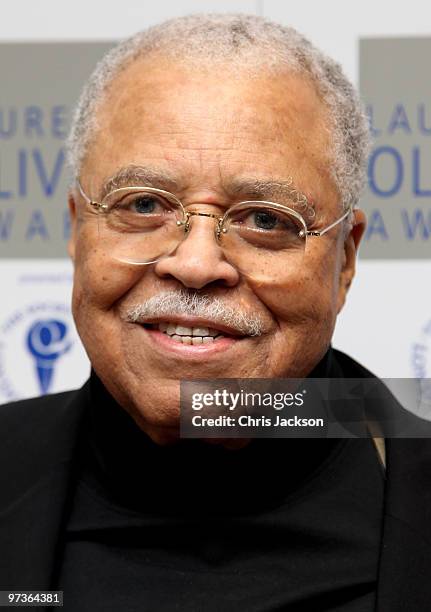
[76,349,342,514]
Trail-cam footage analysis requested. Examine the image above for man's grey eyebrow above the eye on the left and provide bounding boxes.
[100,164,178,199]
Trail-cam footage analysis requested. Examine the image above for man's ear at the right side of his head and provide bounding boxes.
[337,209,367,314]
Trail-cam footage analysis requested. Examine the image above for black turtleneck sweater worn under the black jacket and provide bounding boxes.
[57,355,384,612]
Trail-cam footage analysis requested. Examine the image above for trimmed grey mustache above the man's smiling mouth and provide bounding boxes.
[125,291,264,336]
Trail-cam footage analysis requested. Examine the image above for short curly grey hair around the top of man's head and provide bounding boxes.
[67,14,369,207]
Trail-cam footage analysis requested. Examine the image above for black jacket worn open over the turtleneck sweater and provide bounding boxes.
[0,351,431,612]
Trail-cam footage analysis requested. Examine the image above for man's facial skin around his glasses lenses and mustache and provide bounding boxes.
[70,60,361,442]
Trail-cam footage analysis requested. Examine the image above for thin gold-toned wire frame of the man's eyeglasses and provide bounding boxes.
[76,179,353,241]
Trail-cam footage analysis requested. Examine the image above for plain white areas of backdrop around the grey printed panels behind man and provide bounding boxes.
[0,0,431,402]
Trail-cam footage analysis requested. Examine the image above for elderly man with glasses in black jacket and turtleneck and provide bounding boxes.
[0,15,431,612]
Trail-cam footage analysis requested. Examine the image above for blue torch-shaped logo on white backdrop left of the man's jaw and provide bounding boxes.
[27,319,72,394]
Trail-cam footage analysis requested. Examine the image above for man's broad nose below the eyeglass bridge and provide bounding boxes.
[155,210,239,289]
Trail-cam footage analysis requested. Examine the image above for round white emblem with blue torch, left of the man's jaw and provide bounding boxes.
[0,303,79,403]
